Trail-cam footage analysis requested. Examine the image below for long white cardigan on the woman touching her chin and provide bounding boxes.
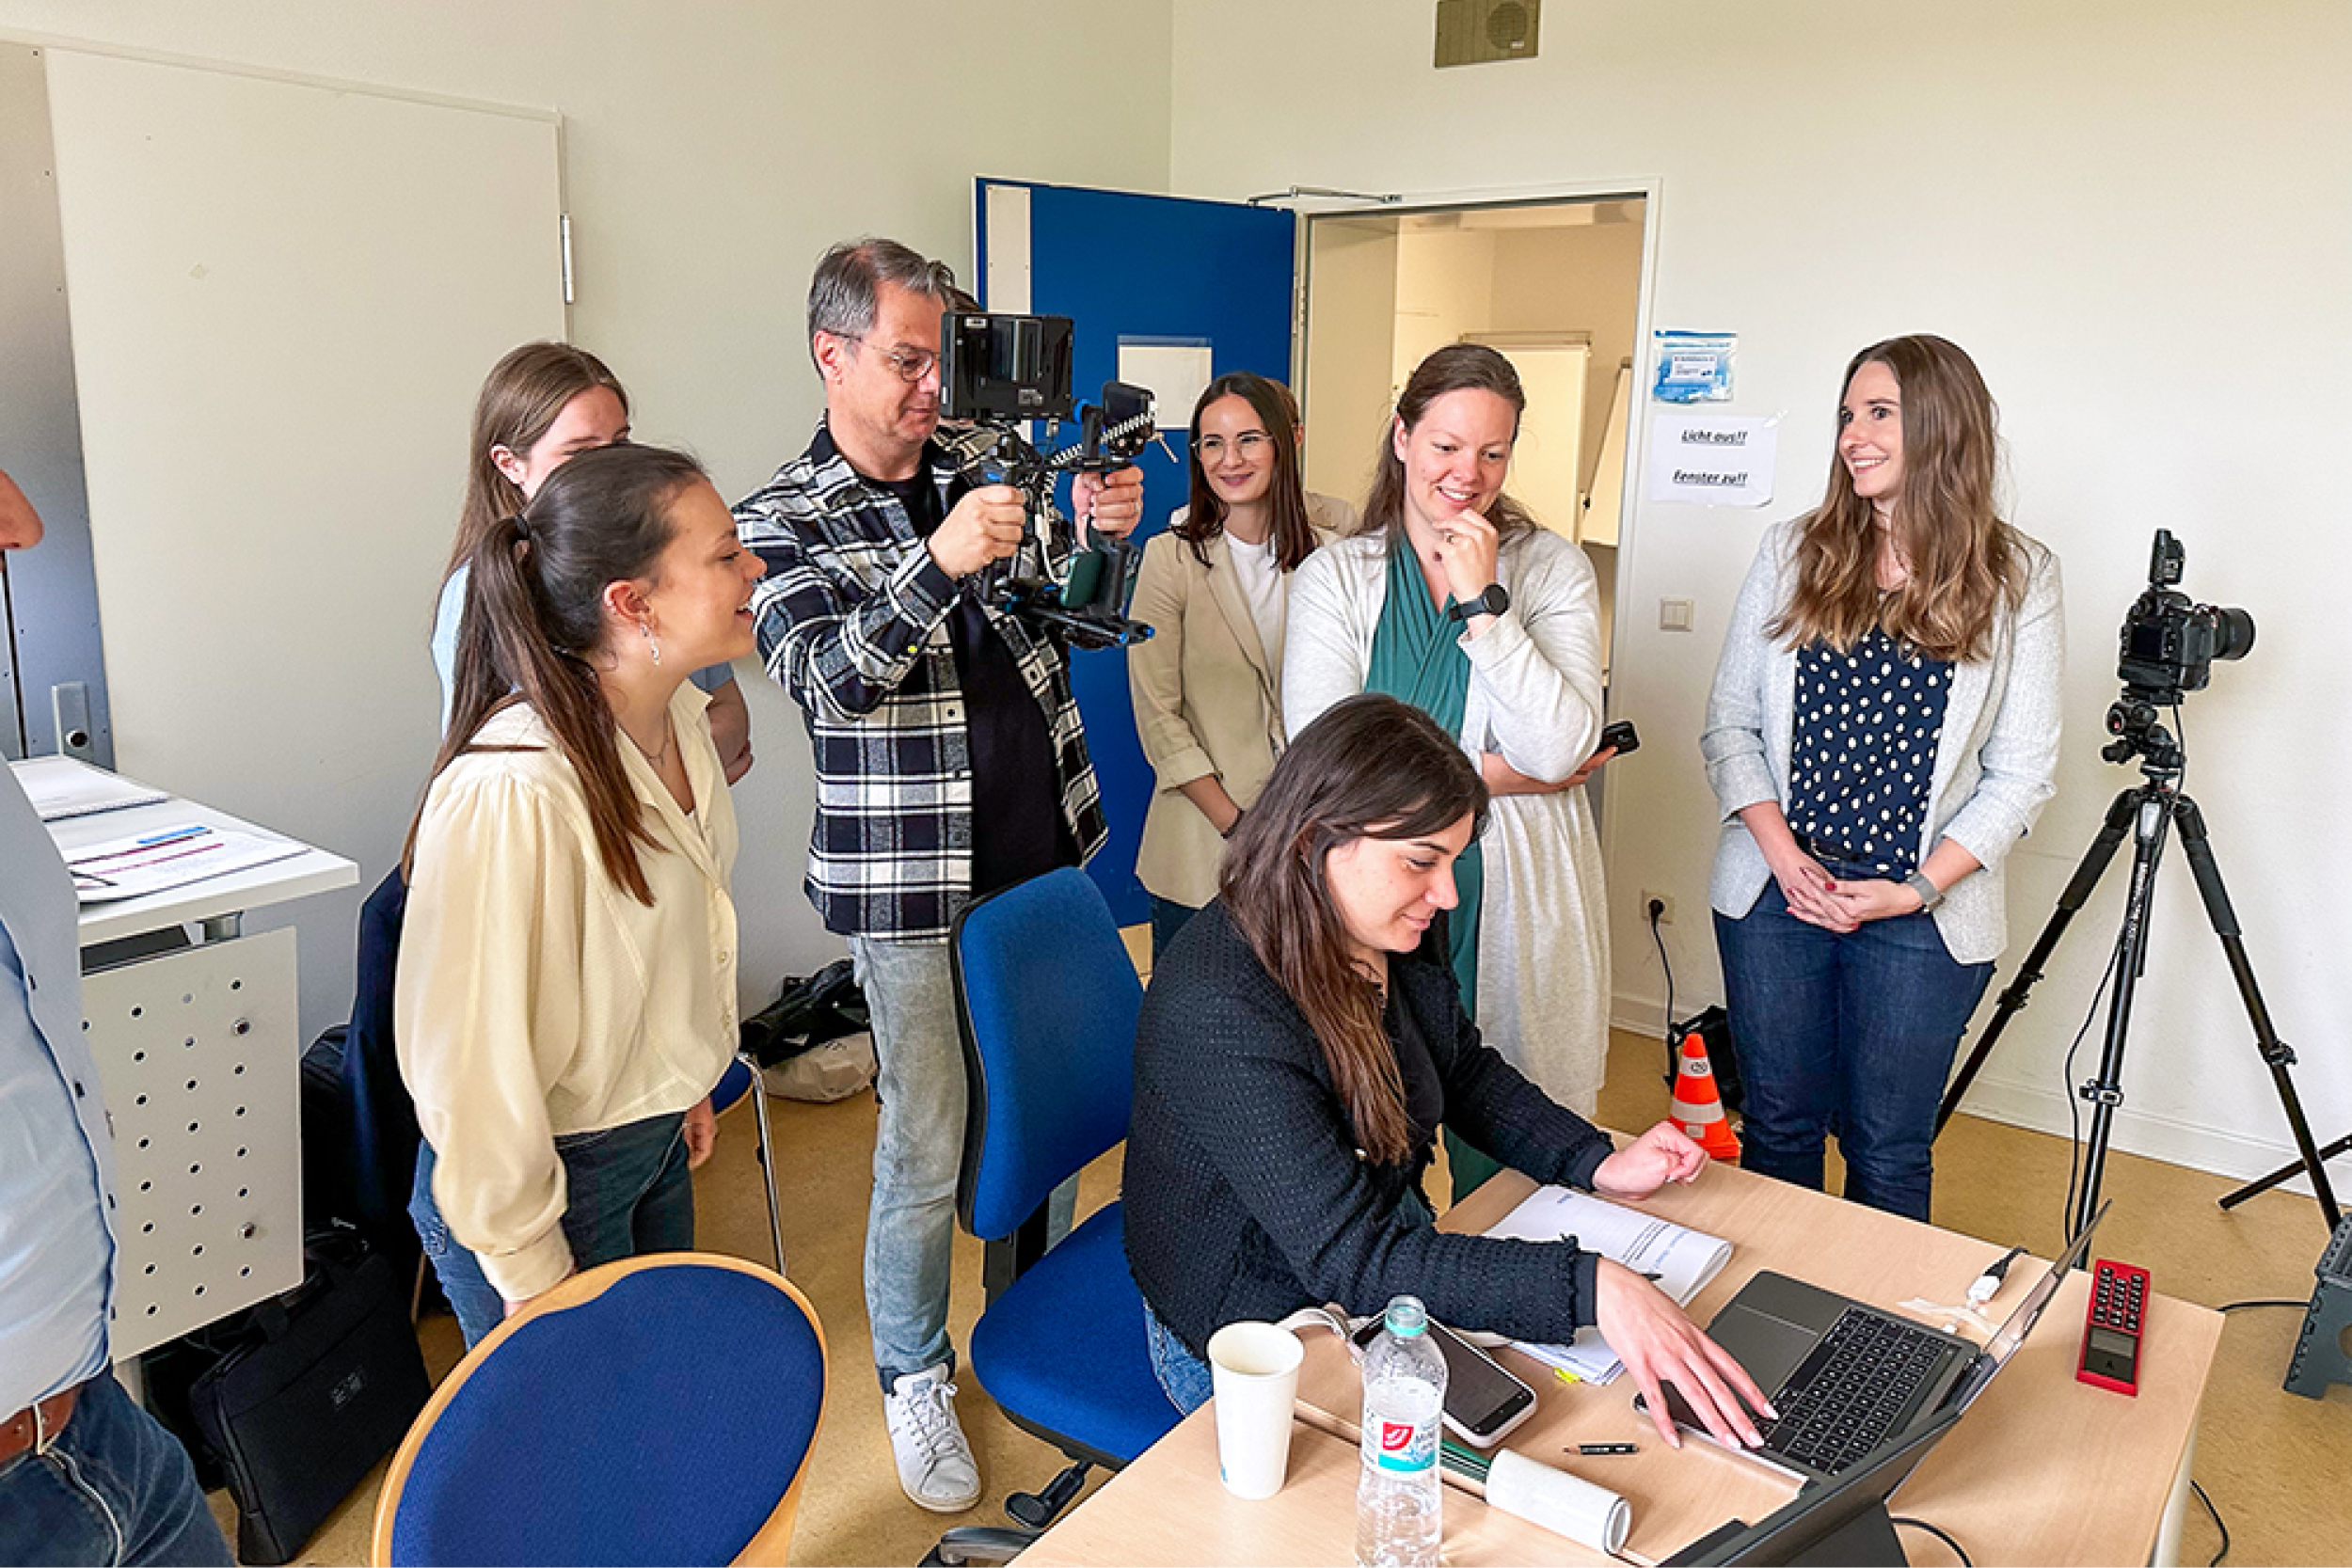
[1282,529,1609,1115]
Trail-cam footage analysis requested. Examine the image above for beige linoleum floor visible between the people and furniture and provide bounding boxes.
[215,933,2352,1566]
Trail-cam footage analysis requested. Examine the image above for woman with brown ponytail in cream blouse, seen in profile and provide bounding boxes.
[393,444,760,1345]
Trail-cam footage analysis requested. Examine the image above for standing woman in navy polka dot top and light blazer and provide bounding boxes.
[1701,336,2065,1220]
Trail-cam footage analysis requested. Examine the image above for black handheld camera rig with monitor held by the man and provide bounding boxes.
[939,310,1160,649]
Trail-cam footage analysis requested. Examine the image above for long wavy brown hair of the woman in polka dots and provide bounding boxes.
[1767,334,2026,660]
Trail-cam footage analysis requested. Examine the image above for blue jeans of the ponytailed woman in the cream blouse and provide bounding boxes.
[409,1112,694,1350]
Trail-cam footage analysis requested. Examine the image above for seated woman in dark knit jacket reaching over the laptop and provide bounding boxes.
[1124,693,1769,1446]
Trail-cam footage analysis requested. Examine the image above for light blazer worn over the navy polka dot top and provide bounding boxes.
[1698,522,2065,964]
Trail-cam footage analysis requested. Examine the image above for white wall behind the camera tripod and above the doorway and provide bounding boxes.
[1171,0,2352,1189]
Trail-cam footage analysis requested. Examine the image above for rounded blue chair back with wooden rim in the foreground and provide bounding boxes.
[372,1253,826,1568]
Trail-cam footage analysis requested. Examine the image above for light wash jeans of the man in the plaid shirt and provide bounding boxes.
[850,936,1077,1394]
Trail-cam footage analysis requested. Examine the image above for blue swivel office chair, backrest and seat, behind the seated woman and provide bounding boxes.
[944,870,1176,1549]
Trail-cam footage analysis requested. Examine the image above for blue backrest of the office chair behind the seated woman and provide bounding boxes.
[950,867,1143,1242]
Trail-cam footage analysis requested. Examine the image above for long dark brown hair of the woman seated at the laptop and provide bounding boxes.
[1216,691,1486,1164]
